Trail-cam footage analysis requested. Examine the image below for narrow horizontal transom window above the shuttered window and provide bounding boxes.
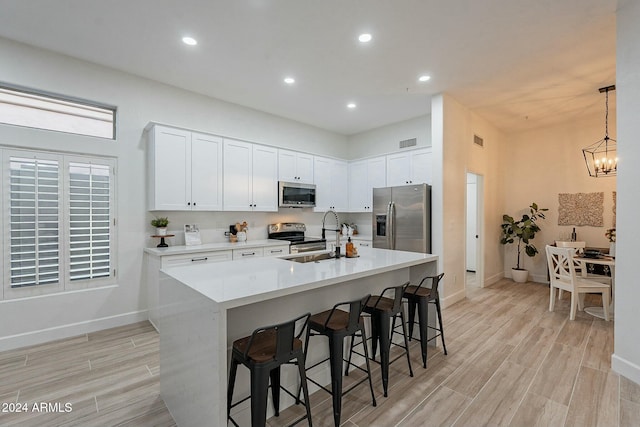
[0,84,116,139]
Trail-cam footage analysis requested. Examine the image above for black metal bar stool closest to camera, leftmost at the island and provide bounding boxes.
[227,313,312,427]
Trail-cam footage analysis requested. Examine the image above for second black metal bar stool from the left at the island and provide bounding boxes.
[298,295,376,427]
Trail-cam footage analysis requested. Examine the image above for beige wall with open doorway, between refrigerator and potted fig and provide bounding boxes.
[431,94,505,305]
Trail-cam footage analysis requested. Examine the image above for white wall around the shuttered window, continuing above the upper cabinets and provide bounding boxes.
[0,39,347,350]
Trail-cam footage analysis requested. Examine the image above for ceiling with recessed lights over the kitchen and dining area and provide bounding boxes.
[0,0,616,135]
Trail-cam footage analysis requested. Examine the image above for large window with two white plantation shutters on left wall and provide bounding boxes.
[0,150,115,299]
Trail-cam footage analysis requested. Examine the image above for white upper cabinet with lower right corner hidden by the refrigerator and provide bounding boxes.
[349,157,386,212]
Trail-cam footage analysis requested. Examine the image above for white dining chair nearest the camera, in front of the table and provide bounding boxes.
[546,245,611,321]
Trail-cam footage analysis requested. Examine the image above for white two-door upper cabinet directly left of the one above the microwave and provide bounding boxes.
[224,140,278,212]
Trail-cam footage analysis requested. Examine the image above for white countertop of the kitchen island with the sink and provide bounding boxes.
[161,248,438,308]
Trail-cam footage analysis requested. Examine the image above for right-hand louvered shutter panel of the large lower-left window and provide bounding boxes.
[68,162,113,281]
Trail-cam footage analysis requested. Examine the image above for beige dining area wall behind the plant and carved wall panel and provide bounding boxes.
[504,112,616,282]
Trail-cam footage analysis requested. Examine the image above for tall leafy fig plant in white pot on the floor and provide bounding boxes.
[500,203,549,283]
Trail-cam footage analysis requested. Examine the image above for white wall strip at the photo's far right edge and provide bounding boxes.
[611,0,640,384]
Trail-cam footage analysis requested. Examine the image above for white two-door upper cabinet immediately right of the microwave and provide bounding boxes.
[313,156,349,212]
